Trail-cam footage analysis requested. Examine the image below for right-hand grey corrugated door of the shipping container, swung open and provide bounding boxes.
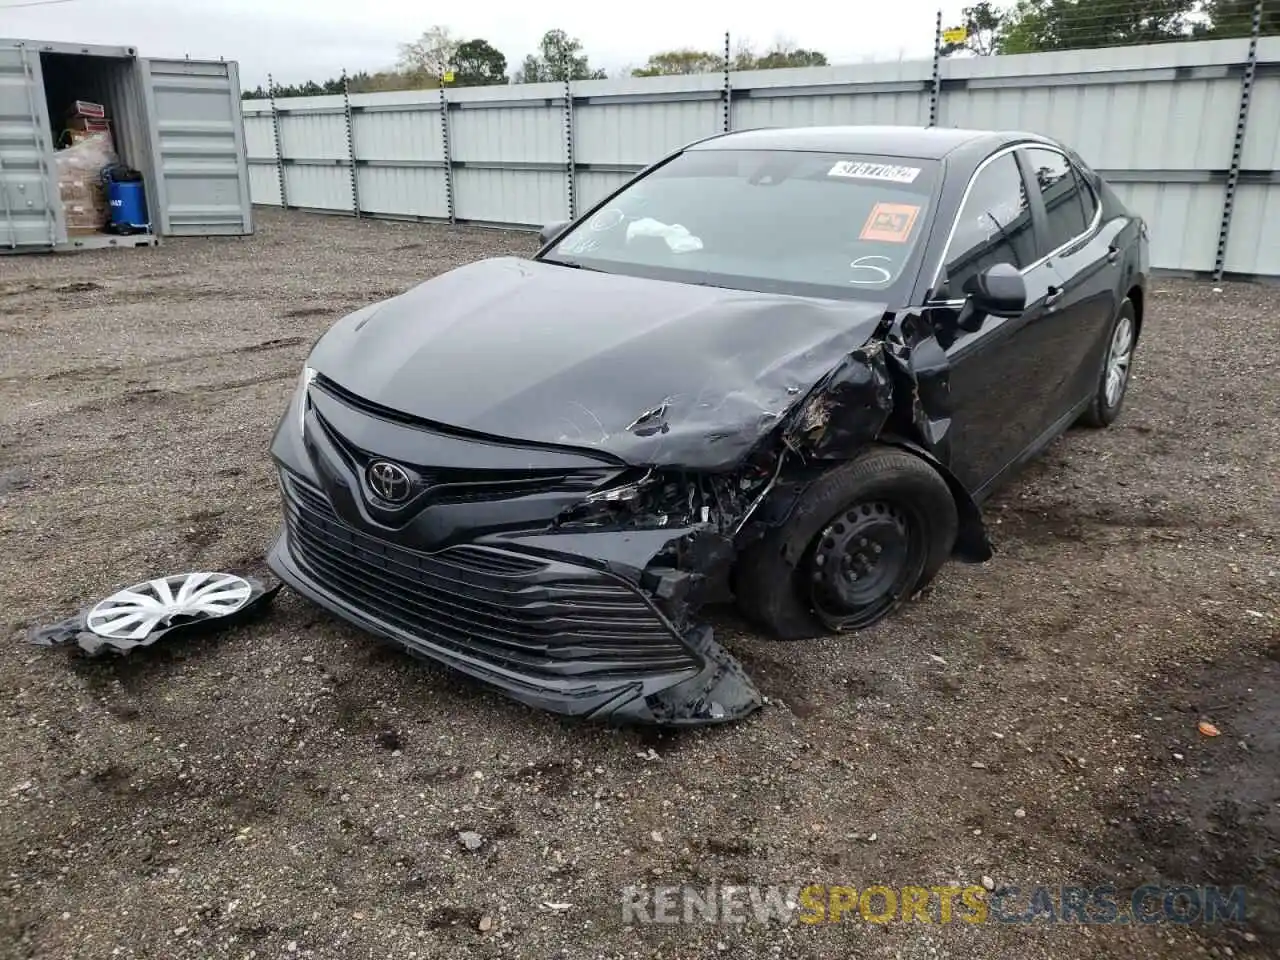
[140,59,253,237]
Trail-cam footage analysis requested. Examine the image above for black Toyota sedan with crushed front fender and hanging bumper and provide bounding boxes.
[270,127,1148,723]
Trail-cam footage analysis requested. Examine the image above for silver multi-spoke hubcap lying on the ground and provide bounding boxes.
[86,573,253,640]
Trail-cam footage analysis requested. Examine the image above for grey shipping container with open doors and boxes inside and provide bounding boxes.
[0,40,253,253]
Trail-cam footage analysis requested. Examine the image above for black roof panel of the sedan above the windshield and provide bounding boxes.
[689,127,1050,160]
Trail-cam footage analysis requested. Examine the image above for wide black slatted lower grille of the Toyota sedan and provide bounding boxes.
[284,474,699,680]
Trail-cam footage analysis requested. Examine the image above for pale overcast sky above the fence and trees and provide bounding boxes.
[0,0,963,87]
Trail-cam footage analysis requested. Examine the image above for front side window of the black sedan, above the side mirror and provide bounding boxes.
[943,152,1038,297]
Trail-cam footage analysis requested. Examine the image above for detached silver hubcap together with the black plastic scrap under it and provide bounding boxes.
[27,572,282,657]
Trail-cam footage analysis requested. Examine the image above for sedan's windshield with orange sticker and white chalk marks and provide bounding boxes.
[543,150,938,301]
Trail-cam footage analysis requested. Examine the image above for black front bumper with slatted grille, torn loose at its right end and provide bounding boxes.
[268,378,760,726]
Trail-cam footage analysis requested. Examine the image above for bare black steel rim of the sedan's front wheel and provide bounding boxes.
[812,502,911,617]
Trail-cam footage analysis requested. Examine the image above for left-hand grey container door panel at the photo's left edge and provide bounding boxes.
[0,41,67,251]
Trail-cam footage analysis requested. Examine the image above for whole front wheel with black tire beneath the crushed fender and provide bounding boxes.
[735,447,959,640]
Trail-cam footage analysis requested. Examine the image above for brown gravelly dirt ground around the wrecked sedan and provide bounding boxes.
[0,211,1280,960]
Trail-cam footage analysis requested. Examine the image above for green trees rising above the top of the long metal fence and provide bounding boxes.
[243,0,1280,100]
